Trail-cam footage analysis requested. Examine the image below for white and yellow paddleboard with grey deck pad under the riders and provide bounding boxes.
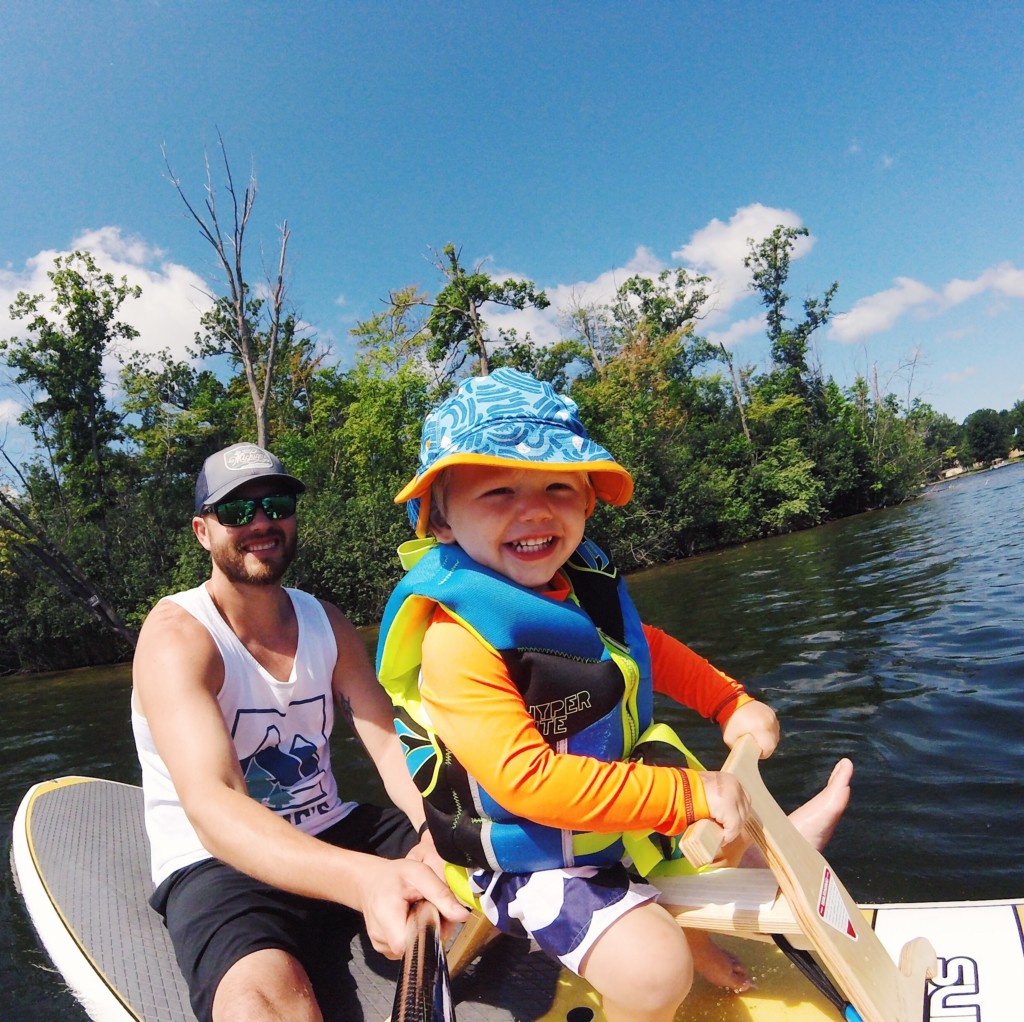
[11,777,1024,1022]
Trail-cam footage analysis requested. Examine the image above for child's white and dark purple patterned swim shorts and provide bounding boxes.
[469,863,658,976]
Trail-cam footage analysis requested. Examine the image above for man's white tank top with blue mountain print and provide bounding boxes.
[132,585,356,884]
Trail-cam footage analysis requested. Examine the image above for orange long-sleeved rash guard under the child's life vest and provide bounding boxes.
[420,593,752,835]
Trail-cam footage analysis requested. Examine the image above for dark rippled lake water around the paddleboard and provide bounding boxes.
[0,464,1024,1022]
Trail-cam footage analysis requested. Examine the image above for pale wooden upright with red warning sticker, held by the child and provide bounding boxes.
[682,734,936,1022]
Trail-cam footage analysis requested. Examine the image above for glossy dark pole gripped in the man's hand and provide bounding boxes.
[391,901,455,1022]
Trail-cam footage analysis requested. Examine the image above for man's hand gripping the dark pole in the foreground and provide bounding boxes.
[359,857,469,960]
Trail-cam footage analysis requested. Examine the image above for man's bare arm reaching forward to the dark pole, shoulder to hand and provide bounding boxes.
[133,602,465,956]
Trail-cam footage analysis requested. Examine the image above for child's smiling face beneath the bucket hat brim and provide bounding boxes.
[433,465,590,590]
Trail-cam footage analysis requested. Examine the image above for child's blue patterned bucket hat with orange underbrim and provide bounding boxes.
[394,369,633,536]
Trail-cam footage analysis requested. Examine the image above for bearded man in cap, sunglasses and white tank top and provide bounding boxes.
[132,443,466,1022]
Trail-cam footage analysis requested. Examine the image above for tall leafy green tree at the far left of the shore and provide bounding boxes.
[0,252,140,644]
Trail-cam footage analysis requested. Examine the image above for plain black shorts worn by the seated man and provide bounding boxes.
[150,805,418,1022]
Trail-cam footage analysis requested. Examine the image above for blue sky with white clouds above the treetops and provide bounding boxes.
[0,0,1024,460]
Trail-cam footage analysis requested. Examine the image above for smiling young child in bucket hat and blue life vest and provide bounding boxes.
[378,369,852,1022]
